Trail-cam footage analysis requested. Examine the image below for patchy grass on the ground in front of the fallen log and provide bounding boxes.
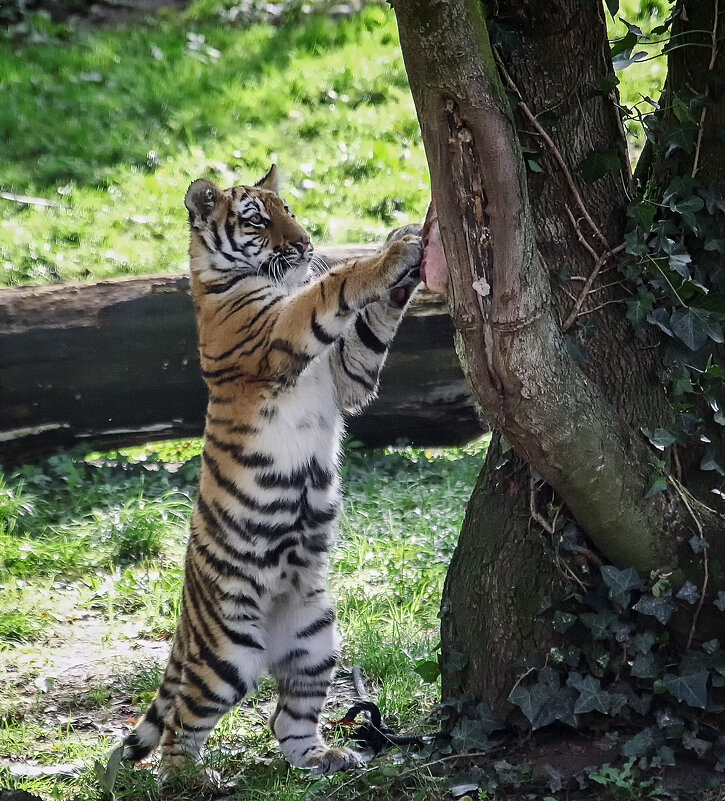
[0,440,486,801]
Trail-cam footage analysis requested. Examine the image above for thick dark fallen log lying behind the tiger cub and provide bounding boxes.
[0,247,482,468]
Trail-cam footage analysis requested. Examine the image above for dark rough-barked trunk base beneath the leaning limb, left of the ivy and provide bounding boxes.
[441,434,562,713]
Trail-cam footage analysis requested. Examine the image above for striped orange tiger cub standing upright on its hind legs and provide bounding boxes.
[123,167,422,776]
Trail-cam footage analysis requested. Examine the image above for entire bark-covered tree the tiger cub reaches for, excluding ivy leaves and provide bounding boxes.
[394,0,725,711]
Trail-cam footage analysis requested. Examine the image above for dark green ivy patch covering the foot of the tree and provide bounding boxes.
[509,552,725,772]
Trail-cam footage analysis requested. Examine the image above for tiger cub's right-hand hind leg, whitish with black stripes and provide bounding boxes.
[269,588,362,773]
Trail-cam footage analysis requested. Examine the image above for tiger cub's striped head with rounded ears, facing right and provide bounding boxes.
[184,165,313,286]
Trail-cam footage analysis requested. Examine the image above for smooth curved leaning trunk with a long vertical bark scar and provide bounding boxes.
[394,0,725,600]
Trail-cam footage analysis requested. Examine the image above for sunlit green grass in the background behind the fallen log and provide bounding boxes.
[0,0,665,286]
